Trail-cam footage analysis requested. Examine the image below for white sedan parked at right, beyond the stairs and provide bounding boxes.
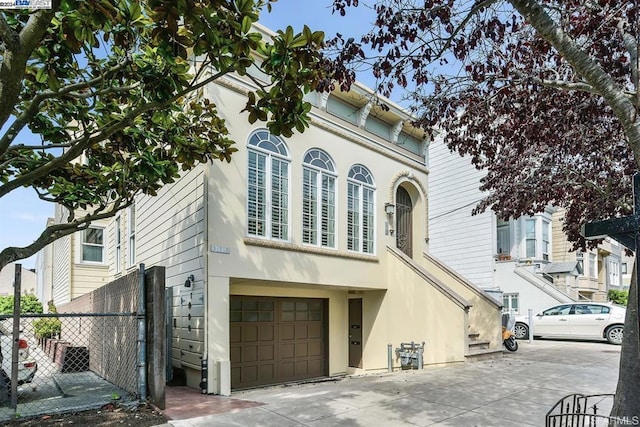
[514,302,626,345]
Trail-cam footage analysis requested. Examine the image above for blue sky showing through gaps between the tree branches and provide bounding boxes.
[0,0,373,268]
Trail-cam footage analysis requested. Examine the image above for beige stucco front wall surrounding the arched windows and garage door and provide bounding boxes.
[192,76,501,394]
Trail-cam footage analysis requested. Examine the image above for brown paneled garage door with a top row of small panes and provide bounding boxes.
[230,296,328,389]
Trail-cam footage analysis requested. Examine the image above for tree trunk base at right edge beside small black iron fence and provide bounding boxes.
[609,258,640,426]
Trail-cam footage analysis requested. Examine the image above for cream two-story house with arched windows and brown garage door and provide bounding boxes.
[38,27,502,394]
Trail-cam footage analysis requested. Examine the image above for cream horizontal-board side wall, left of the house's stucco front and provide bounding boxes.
[134,166,206,369]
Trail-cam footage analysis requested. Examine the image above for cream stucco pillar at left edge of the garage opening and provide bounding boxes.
[206,276,231,396]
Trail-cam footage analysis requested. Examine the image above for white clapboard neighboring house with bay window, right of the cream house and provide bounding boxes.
[429,141,571,314]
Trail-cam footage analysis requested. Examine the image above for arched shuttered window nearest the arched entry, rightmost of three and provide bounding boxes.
[347,165,375,254]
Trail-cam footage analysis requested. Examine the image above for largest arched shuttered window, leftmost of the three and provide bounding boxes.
[247,129,290,240]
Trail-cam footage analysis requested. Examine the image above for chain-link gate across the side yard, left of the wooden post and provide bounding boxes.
[0,313,138,421]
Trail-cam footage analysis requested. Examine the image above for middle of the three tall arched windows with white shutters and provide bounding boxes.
[302,148,336,248]
